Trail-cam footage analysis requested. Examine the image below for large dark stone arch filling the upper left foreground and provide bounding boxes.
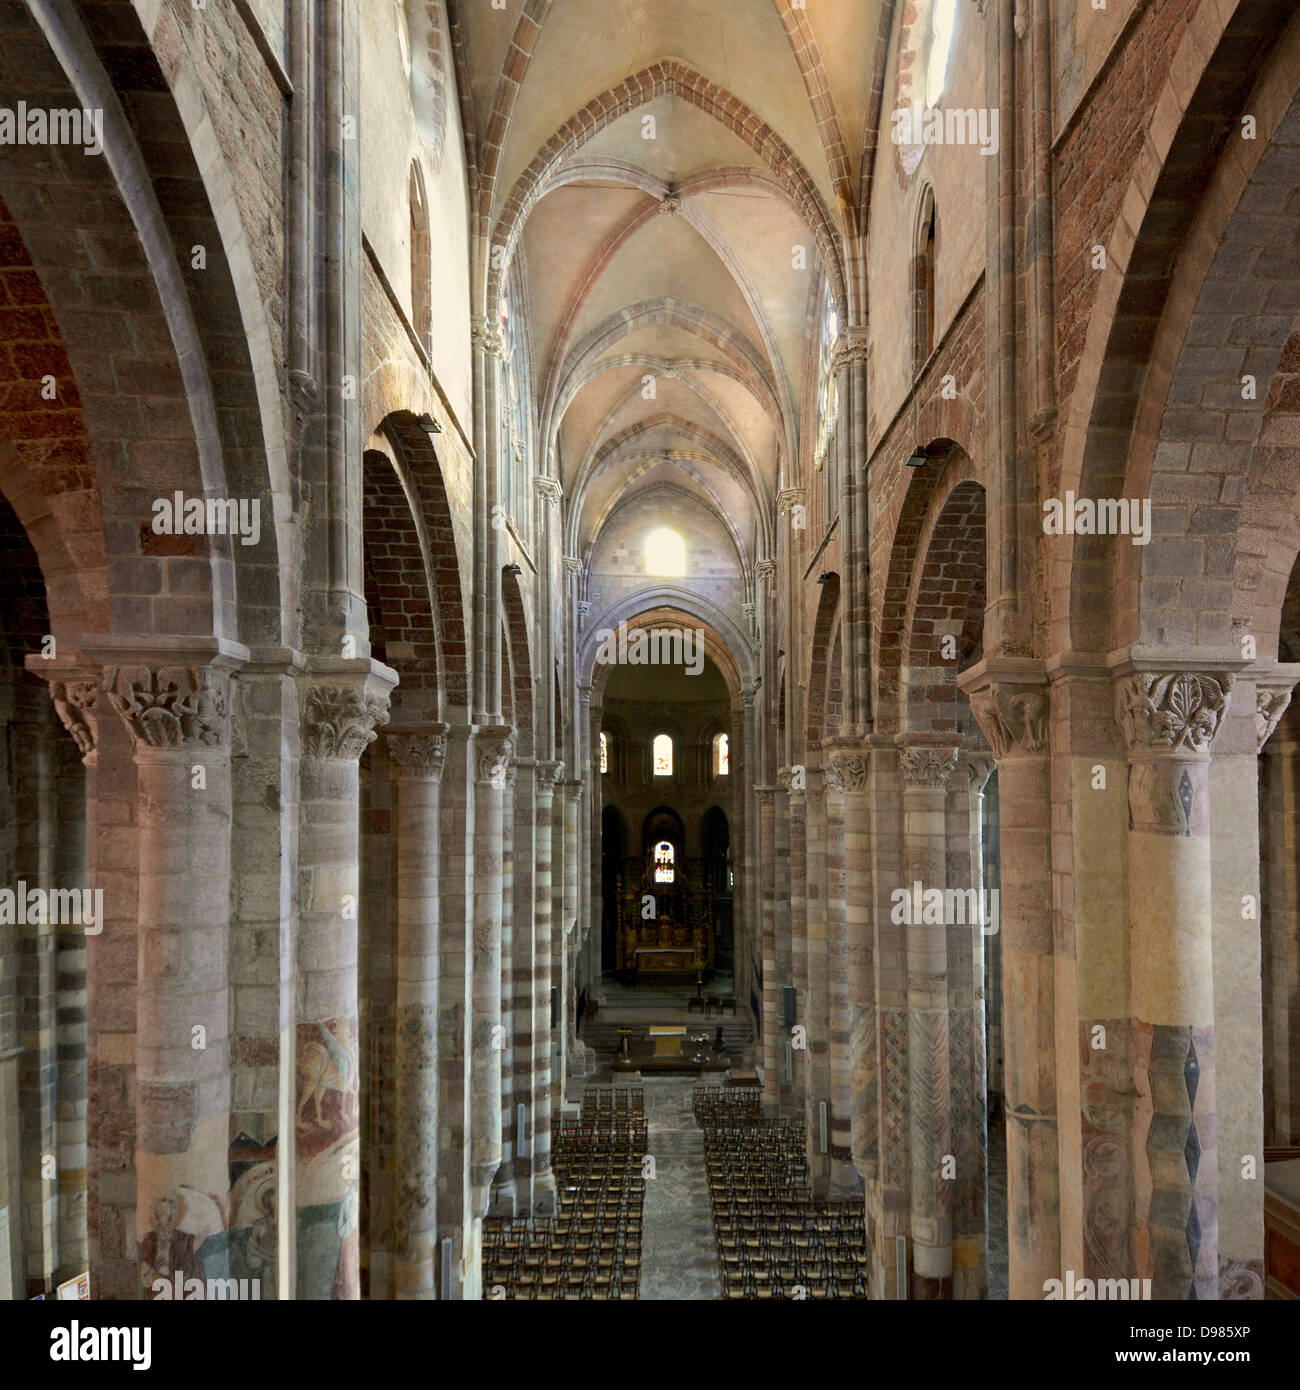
[0,4,312,645]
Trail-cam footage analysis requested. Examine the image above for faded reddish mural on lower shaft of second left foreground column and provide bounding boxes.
[295,1019,361,1298]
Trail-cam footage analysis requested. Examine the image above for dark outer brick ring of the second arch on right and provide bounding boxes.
[872,442,983,731]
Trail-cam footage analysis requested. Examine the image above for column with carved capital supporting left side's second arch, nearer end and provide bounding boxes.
[381,724,446,1300]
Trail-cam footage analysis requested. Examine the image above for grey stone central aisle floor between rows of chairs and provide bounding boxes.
[641,1076,722,1301]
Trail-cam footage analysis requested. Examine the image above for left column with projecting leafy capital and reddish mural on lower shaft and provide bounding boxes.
[298,660,393,1298]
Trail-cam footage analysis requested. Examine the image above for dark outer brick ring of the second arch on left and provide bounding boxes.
[381,410,470,712]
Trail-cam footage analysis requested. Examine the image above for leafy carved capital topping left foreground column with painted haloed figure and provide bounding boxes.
[106,666,231,749]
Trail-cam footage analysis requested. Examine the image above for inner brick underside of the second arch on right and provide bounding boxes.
[898,474,987,734]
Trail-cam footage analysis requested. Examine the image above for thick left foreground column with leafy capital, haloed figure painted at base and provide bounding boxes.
[104,652,239,1298]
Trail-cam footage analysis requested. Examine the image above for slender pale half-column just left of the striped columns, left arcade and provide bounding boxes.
[470,727,513,1218]
